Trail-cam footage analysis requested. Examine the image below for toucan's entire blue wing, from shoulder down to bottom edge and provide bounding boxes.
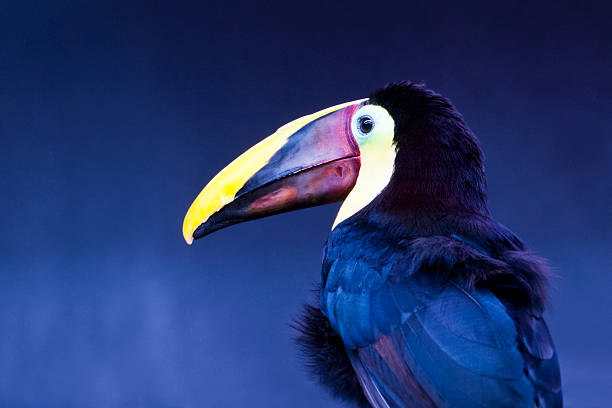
[322,237,561,408]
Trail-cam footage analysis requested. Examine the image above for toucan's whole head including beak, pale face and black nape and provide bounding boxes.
[183,82,487,244]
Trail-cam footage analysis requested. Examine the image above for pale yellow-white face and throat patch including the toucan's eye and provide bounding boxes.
[332,105,396,230]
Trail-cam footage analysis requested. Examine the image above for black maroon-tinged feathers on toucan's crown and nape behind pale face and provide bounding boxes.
[369,82,488,215]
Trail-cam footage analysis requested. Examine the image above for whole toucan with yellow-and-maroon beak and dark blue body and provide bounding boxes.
[183,82,563,408]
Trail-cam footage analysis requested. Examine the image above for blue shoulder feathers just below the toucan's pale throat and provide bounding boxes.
[320,223,441,349]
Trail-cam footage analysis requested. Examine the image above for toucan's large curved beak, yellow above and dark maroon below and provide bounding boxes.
[183,99,365,244]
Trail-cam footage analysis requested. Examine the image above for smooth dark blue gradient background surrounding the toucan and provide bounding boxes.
[0,0,612,408]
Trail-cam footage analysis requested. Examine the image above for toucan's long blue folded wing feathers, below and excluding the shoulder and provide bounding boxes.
[350,287,562,408]
